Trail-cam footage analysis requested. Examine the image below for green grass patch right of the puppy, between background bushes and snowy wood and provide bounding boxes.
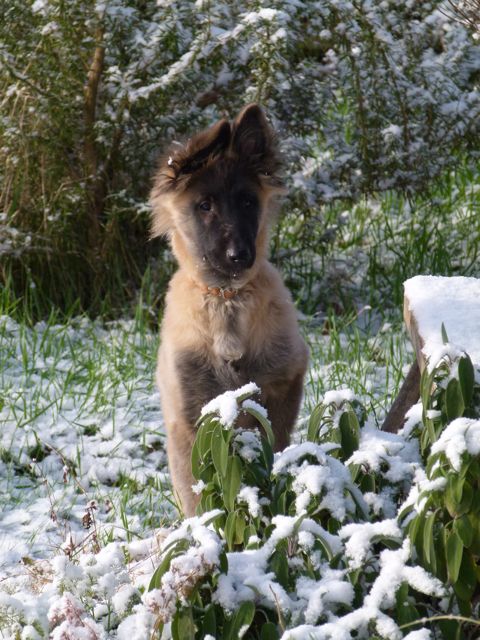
[273,163,480,321]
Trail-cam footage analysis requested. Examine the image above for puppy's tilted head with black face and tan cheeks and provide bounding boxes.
[151,105,283,286]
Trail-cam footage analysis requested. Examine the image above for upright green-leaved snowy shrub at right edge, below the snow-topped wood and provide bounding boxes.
[400,344,480,637]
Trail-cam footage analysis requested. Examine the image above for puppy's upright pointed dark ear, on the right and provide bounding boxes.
[232,104,281,181]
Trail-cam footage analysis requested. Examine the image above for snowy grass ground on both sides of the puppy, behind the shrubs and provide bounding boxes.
[0,316,412,640]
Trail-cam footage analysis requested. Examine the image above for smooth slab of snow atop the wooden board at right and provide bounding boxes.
[404,276,480,369]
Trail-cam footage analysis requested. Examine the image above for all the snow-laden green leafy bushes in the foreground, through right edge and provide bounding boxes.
[144,347,480,640]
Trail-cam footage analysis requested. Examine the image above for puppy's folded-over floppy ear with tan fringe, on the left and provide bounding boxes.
[150,120,231,237]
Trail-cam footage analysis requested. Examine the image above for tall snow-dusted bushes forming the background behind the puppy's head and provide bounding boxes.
[0,0,480,311]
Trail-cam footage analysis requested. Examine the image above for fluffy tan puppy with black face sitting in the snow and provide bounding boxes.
[151,104,308,516]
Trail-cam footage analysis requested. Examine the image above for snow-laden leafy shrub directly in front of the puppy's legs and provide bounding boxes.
[144,385,446,640]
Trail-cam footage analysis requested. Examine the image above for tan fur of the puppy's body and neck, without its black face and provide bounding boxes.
[152,105,308,515]
